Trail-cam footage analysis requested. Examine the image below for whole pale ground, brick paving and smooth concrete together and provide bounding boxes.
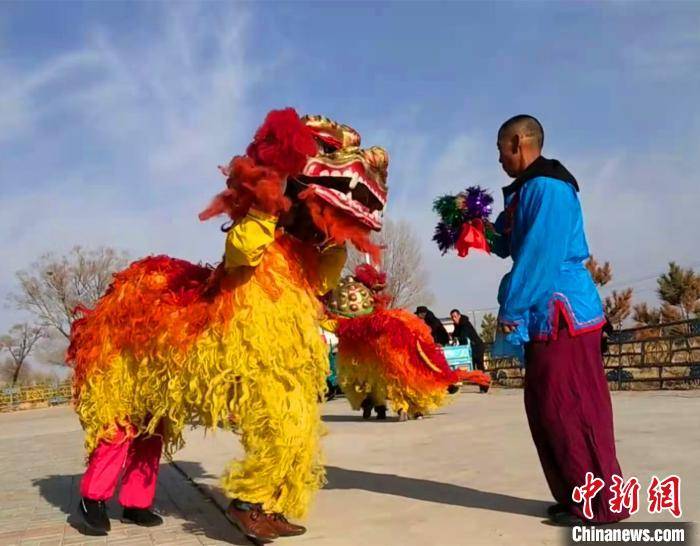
[0,384,700,546]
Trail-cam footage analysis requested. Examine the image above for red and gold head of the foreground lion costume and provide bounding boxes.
[200,108,389,258]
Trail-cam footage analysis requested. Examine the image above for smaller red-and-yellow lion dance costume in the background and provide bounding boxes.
[327,264,491,421]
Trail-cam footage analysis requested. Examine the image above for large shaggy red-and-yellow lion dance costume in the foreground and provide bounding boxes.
[68,109,388,539]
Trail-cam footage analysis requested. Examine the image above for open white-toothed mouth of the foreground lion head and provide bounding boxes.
[297,160,386,230]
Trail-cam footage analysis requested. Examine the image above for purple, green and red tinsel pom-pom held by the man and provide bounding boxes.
[433,186,495,258]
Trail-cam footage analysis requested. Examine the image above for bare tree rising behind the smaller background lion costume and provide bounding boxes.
[346,220,433,308]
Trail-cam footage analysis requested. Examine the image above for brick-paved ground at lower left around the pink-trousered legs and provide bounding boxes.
[0,406,248,546]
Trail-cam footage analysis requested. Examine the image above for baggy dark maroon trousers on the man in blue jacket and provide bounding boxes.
[525,328,629,523]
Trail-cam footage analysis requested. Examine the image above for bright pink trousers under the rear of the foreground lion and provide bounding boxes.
[80,429,163,508]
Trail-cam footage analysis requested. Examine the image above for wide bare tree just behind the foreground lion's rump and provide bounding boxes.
[10,247,128,339]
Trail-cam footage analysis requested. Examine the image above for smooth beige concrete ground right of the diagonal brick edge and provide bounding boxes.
[176,387,700,546]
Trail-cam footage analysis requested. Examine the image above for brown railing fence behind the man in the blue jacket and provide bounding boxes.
[486,319,700,390]
